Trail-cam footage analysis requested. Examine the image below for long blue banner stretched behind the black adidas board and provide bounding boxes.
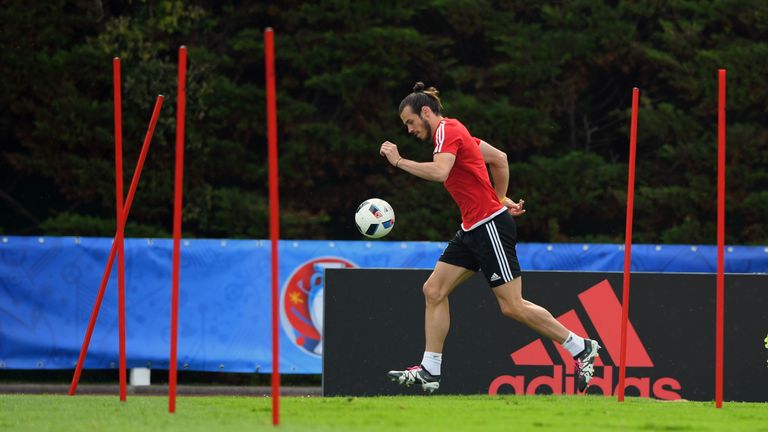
[0,237,768,374]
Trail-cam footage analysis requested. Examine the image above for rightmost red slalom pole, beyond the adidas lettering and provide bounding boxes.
[715,69,725,408]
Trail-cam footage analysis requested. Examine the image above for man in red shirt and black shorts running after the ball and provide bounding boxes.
[380,82,600,393]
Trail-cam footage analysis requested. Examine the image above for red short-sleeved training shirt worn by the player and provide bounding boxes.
[433,118,507,231]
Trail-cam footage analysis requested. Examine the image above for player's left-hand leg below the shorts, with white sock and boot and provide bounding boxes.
[389,261,475,392]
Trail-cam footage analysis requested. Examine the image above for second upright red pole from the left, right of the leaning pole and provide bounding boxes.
[168,45,187,413]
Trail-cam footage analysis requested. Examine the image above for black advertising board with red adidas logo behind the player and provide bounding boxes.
[323,269,768,401]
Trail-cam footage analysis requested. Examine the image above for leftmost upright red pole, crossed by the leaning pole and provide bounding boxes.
[112,57,128,402]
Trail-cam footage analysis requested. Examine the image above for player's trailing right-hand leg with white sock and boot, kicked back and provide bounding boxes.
[493,277,600,391]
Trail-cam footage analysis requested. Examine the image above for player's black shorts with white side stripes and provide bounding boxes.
[439,212,522,288]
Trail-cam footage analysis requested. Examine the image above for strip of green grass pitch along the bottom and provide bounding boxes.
[0,395,768,432]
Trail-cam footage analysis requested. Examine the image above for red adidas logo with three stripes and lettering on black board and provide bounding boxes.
[488,280,681,400]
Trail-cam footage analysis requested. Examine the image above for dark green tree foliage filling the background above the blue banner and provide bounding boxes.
[0,0,768,244]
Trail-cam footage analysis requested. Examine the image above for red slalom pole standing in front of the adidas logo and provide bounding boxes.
[618,87,640,402]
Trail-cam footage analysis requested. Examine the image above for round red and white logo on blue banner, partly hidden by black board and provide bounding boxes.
[280,257,357,357]
